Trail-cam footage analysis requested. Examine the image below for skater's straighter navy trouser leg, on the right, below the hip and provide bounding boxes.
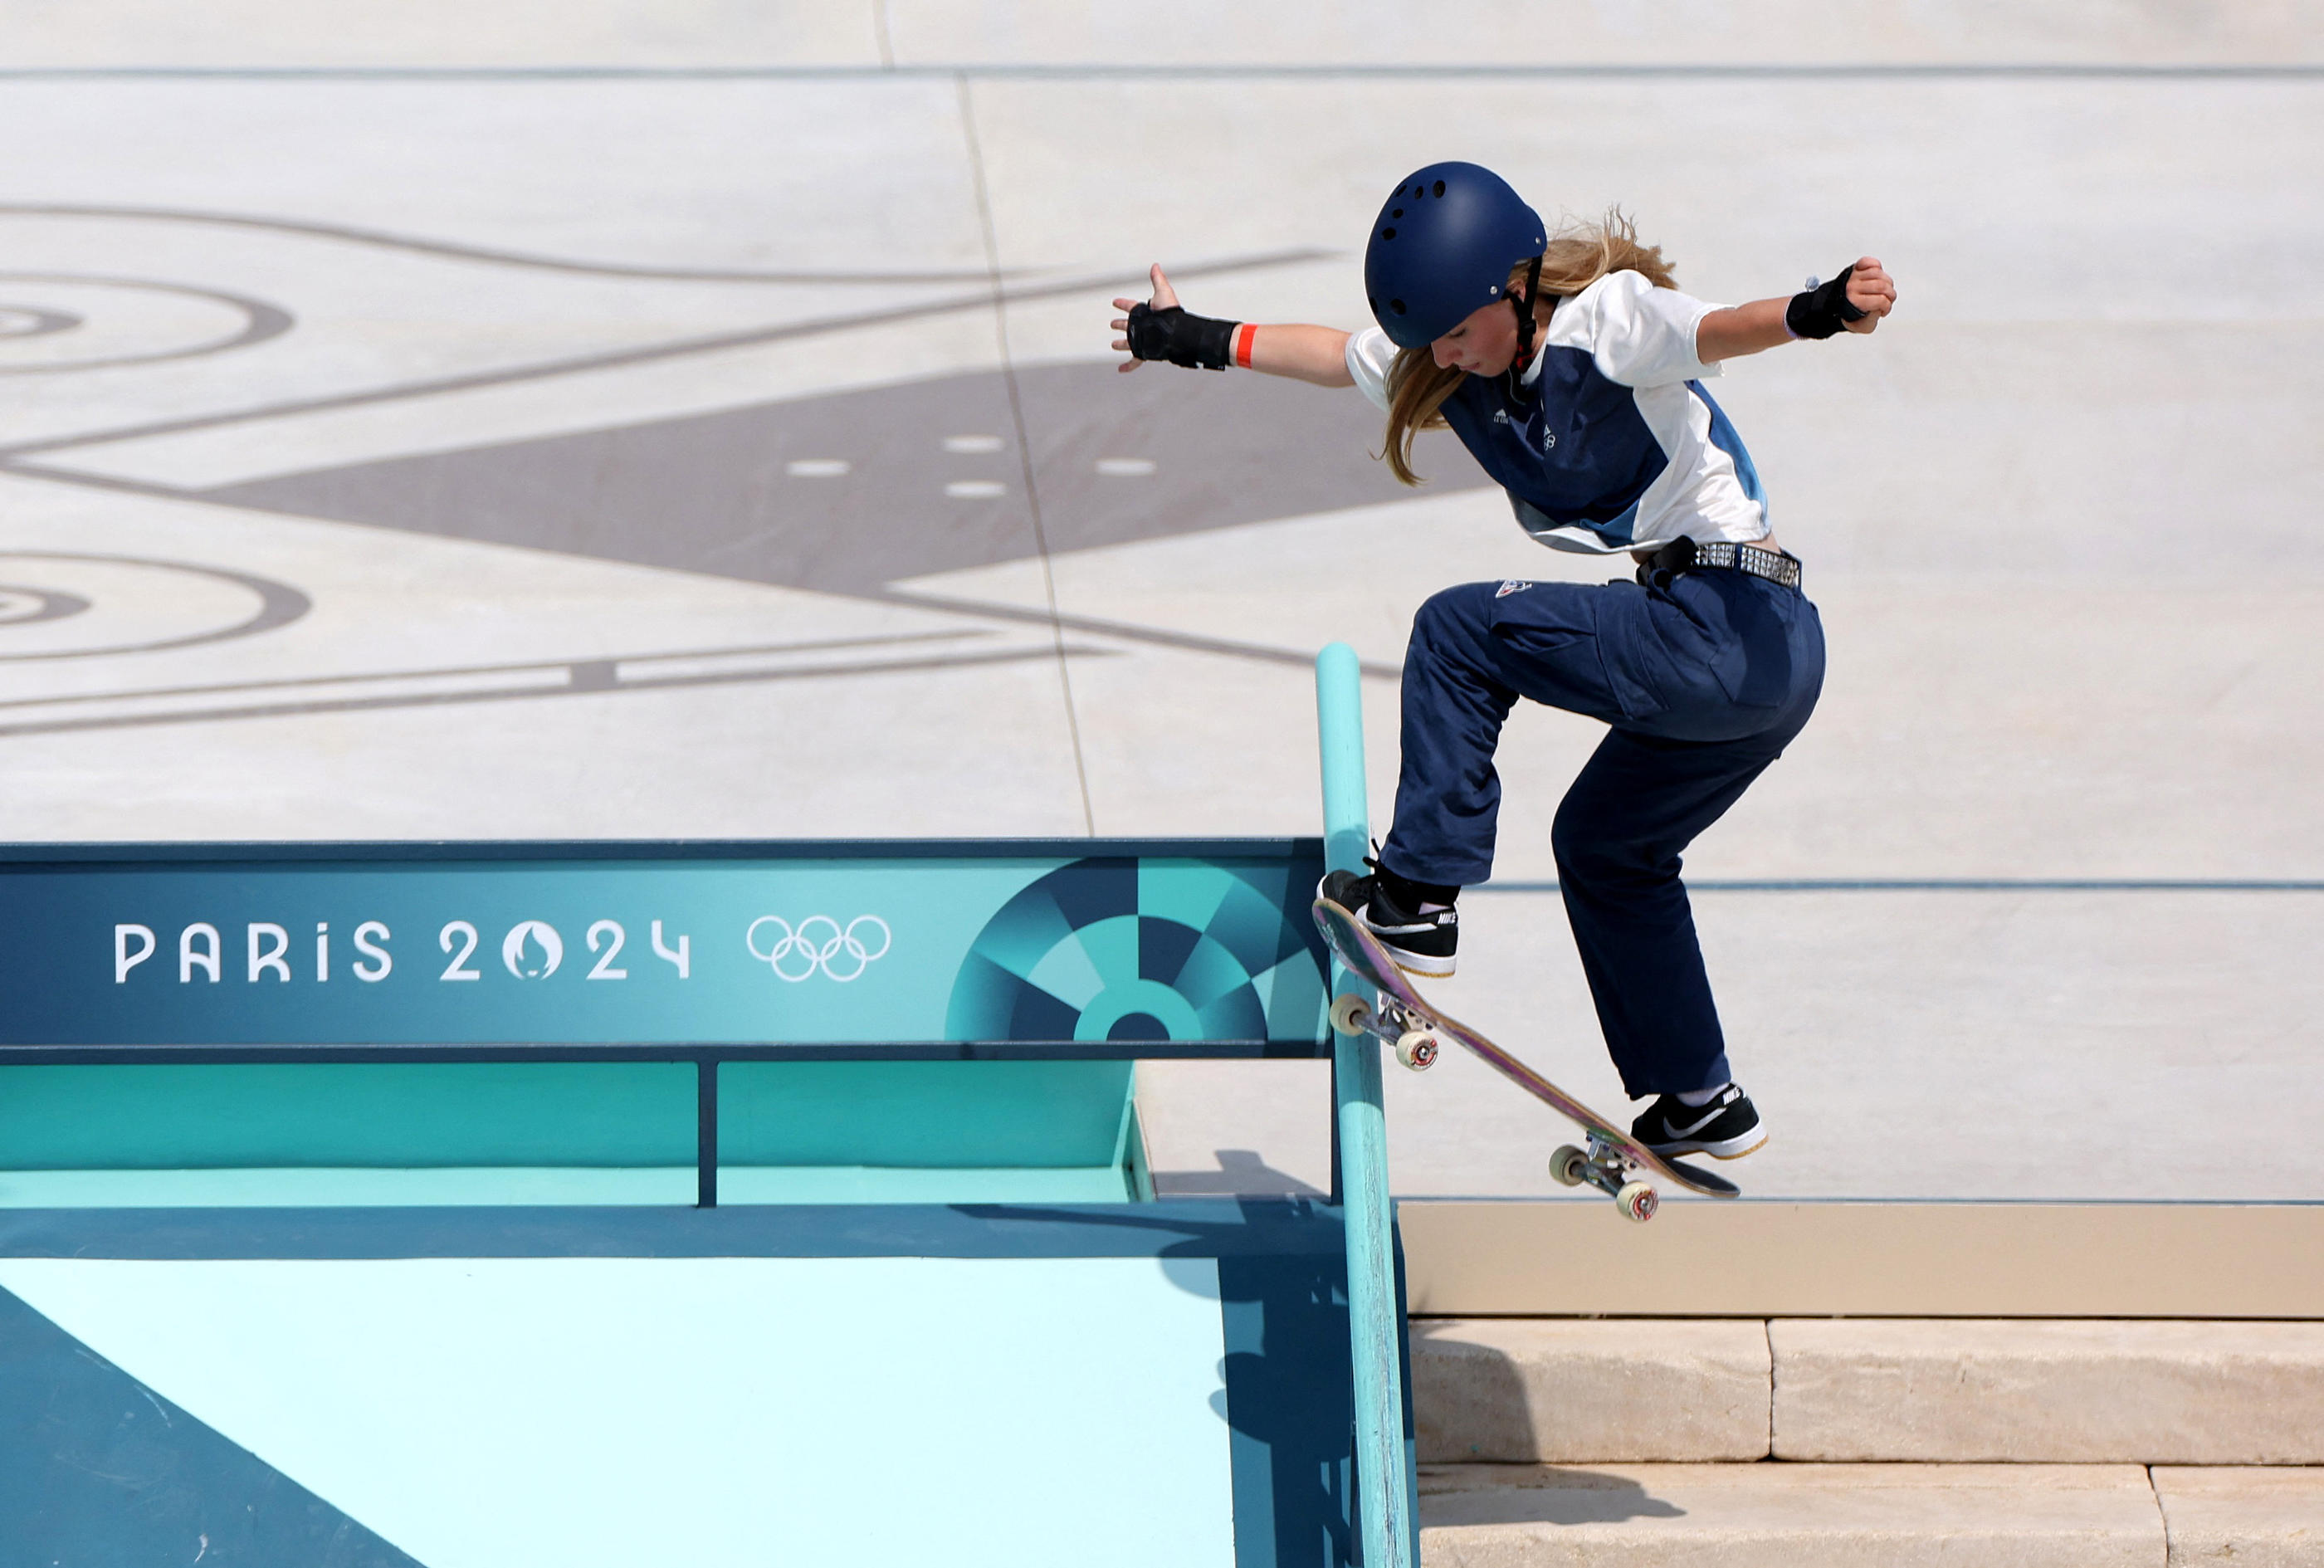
[1550,716,1806,1099]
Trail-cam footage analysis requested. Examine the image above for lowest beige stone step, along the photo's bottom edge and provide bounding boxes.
[1420,1463,2324,1568]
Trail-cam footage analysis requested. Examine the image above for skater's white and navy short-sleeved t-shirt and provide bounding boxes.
[1348,271,1771,555]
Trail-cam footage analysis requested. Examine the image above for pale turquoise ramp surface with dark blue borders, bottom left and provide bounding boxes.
[0,1201,1384,1568]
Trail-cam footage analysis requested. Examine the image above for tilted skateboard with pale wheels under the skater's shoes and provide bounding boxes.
[1316,899,1743,1222]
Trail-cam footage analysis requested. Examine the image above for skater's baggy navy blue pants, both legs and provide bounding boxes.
[1380,571,1824,1099]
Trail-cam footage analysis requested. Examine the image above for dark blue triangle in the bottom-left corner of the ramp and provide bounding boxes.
[0,1292,421,1568]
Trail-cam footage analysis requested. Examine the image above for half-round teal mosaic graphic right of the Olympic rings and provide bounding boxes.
[946,859,1327,1045]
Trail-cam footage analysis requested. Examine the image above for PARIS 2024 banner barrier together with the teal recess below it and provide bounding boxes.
[0,838,1330,1205]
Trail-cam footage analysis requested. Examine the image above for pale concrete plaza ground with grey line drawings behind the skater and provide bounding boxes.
[0,0,2324,1199]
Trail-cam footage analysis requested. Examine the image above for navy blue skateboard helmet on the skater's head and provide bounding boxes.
[1365,163,1550,349]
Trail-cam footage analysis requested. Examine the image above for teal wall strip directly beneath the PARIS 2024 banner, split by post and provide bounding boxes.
[0,1062,1132,1170]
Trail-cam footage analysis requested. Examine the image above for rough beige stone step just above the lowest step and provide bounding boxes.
[1411,1317,2324,1466]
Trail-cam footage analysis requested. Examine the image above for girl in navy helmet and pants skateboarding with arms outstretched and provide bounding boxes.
[1113,163,1897,1159]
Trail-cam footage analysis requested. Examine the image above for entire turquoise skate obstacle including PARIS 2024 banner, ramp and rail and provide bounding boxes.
[0,678,1418,1568]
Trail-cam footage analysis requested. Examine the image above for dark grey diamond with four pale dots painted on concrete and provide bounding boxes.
[207,363,1485,593]
